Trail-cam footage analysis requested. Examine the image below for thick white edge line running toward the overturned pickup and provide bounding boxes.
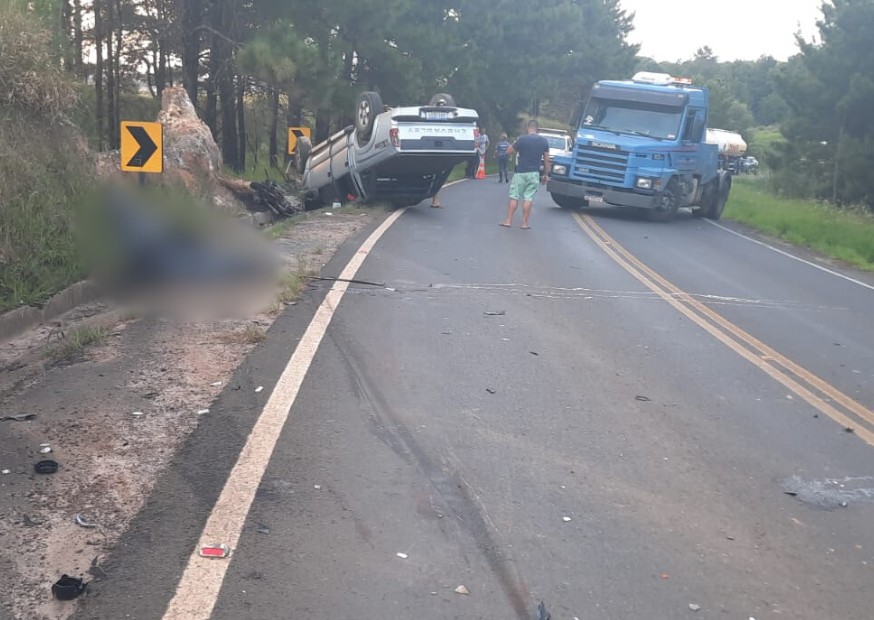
[163,209,406,620]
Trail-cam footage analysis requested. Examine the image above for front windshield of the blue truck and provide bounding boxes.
[582,99,683,140]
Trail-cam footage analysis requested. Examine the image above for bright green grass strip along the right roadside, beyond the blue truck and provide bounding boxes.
[725,177,874,271]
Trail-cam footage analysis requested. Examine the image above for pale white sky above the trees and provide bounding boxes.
[620,0,822,62]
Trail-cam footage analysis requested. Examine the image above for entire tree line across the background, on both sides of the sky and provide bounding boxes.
[11,0,874,204]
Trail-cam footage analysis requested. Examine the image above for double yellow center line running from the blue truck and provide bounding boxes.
[574,213,874,446]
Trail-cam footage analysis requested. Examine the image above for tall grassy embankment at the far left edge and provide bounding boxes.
[0,2,94,312]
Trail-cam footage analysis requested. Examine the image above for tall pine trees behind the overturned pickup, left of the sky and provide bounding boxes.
[31,0,637,169]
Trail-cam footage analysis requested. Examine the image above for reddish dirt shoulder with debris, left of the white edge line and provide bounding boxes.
[0,212,377,620]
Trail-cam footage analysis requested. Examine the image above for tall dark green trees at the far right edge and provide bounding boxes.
[777,0,874,209]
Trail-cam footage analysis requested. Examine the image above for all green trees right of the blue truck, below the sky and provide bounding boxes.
[640,0,874,208]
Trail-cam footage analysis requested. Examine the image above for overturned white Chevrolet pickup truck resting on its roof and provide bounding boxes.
[296,92,479,206]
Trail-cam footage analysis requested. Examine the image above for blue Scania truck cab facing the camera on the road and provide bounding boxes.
[546,72,731,222]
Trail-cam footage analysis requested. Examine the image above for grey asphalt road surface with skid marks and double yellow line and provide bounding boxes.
[77,179,874,620]
